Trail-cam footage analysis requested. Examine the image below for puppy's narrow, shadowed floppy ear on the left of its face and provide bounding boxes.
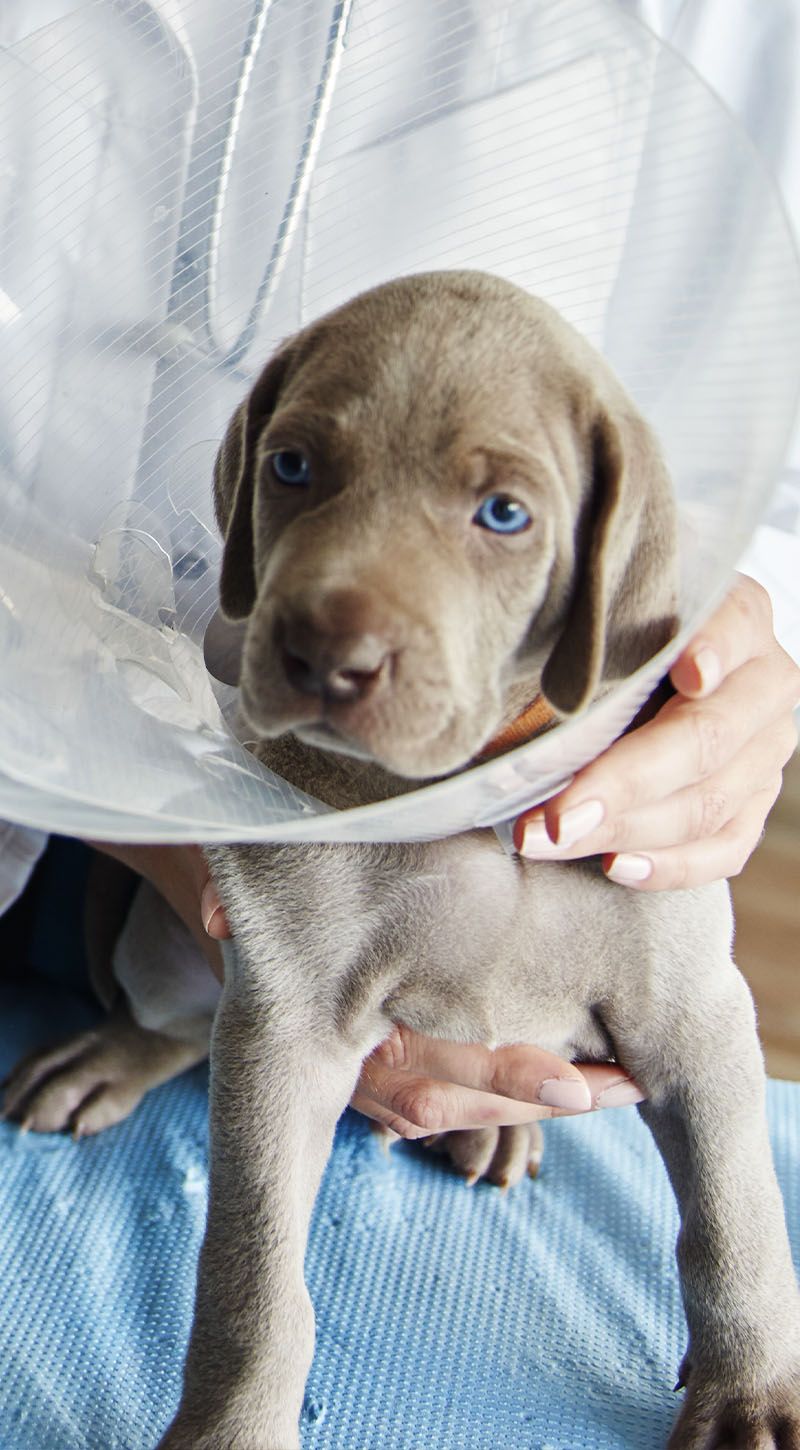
[214,347,291,619]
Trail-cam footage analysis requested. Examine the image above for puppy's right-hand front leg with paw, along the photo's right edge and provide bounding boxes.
[620,963,800,1450]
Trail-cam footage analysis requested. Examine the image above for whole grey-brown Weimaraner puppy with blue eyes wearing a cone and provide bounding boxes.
[10,273,800,1450]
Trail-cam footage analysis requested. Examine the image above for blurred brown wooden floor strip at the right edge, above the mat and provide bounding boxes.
[732,754,800,1080]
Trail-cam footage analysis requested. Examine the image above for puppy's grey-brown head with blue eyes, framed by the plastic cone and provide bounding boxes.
[214,273,675,777]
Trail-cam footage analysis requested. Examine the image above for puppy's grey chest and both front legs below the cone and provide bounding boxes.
[171,832,797,1447]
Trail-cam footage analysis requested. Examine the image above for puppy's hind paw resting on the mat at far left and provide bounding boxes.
[3,1019,203,1138]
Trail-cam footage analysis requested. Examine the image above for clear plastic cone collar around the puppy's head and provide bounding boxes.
[0,0,800,841]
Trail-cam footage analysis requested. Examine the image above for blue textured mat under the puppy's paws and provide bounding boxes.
[0,982,800,1450]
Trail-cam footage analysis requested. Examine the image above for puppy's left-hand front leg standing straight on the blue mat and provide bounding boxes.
[161,954,372,1450]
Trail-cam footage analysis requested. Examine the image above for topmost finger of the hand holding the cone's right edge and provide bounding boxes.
[670,574,775,699]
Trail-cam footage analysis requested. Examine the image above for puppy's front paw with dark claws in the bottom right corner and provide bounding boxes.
[667,1373,800,1450]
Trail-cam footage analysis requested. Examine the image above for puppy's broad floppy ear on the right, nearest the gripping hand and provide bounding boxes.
[542,410,677,715]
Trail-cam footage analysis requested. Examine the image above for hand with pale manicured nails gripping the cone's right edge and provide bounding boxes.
[514,574,800,890]
